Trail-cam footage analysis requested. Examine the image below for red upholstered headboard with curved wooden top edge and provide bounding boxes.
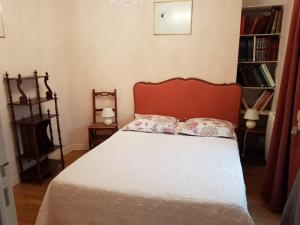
[133,78,242,125]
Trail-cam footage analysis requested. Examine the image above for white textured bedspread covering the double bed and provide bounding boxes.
[36,131,253,225]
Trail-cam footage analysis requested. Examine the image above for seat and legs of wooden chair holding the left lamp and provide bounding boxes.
[88,123,118,150]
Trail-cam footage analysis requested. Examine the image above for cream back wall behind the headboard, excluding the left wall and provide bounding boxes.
[69,0,242,144]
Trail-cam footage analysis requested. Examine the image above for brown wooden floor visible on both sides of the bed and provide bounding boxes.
[14,151,280,225]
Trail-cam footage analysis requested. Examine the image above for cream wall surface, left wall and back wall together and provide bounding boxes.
[0,0,242,182]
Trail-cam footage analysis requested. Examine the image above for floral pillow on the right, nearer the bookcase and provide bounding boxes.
[179,118,235,138]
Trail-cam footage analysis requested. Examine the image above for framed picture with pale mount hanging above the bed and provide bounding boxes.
[154,0,193,35]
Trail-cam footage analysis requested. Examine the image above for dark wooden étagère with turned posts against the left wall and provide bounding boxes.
[4,71,64,182]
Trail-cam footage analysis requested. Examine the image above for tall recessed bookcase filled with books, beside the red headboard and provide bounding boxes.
[237,5,283,161]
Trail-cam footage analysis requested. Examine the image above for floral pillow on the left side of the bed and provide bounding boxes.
[124,114,178,134]
